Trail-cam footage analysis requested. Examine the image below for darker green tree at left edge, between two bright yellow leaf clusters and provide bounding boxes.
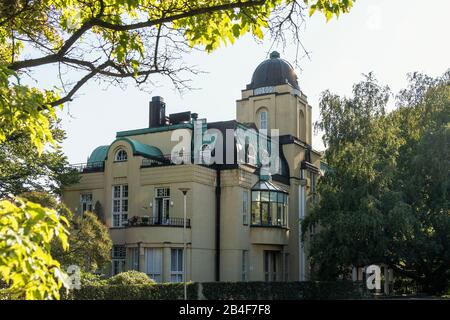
[0,119,79,198]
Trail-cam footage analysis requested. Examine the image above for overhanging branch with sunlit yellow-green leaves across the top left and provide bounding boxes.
[0,0,353,151]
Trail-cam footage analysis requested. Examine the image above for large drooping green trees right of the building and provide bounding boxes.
[302,72,450,293]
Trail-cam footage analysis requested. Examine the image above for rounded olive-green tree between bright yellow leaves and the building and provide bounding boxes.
[23,192,112,272]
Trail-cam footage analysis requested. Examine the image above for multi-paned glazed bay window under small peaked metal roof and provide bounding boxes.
[251,191,288,227]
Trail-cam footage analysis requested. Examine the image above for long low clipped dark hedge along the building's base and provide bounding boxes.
[65,281,370,300]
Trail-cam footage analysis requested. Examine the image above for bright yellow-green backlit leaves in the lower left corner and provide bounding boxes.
[0,198,68,299]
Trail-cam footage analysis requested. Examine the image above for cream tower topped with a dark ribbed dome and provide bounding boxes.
[236,51,312,145]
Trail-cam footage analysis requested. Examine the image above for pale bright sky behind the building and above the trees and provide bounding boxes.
[48,0,450,163]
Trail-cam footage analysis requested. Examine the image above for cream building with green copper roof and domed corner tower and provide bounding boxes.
[63,52,320,282]
